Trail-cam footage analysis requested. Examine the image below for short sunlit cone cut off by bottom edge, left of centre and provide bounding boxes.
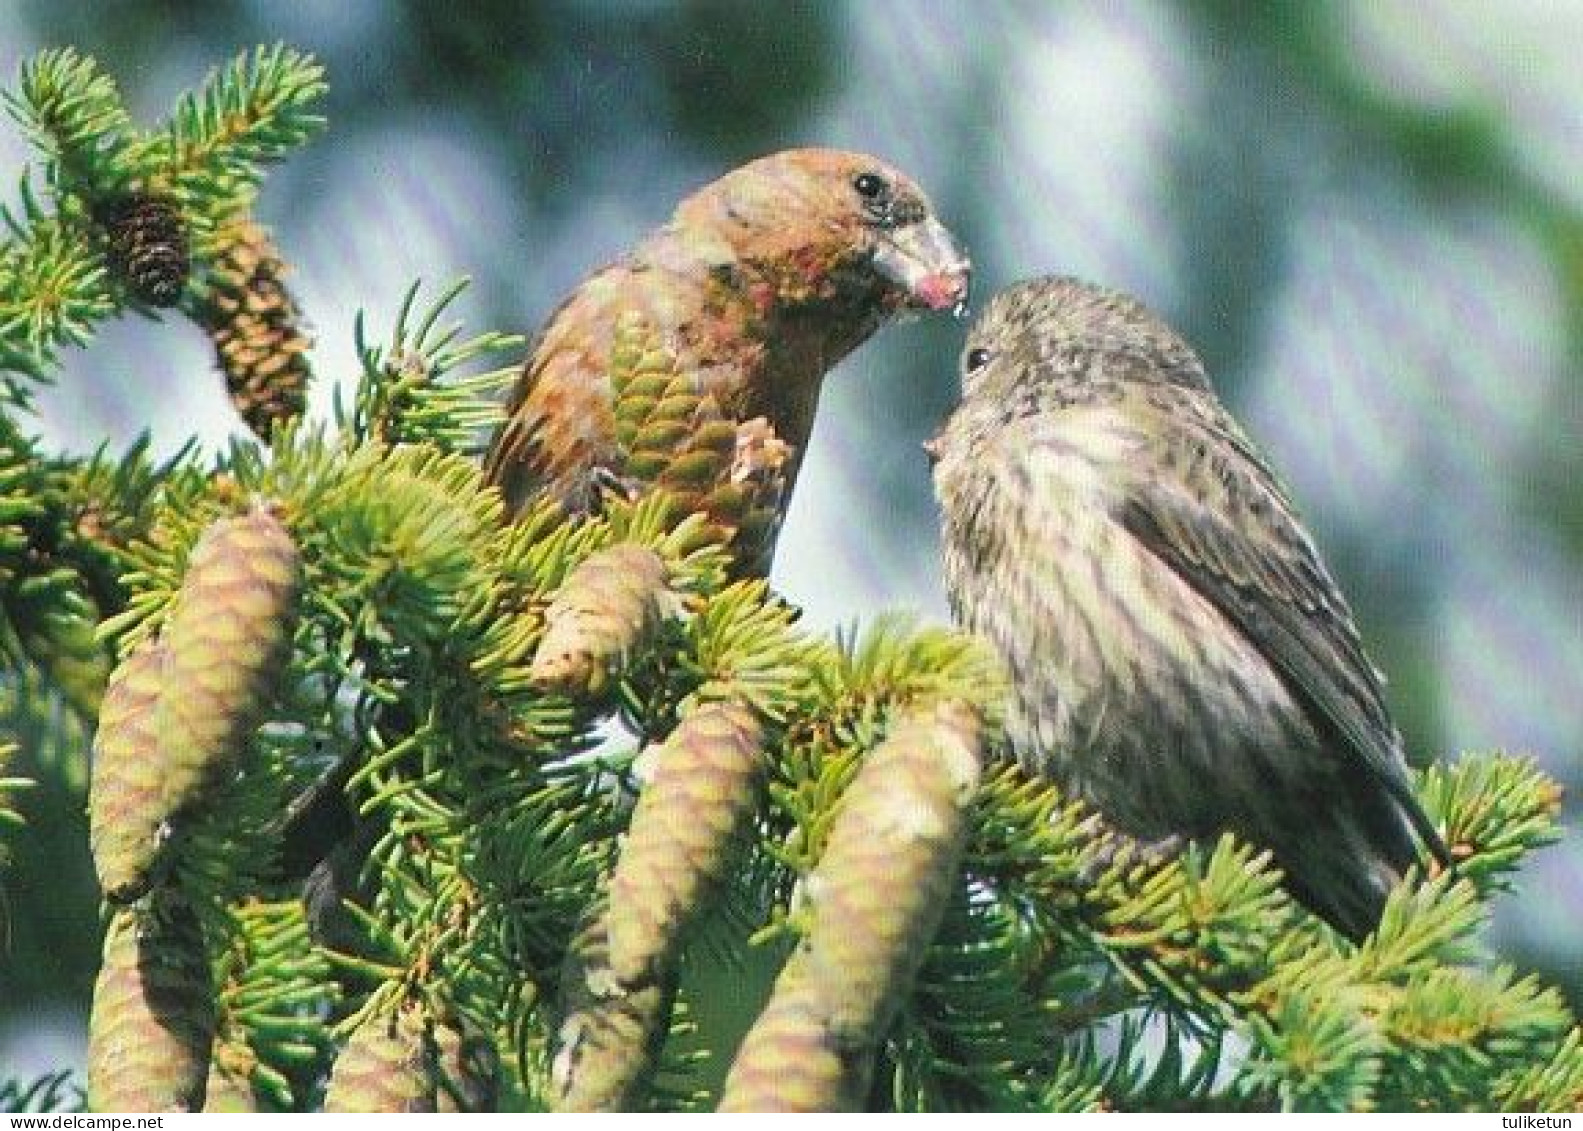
[325,1006,435,1112]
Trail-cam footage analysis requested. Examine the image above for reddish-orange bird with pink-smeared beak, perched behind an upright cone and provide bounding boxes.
[484,149,969,573]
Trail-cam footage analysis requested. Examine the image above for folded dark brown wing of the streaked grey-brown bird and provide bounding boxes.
[1118,396,1445,859]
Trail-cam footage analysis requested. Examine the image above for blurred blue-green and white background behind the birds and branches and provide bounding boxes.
[0,0,1583,1077]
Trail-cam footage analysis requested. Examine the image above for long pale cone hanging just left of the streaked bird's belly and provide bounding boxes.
[801,700,981,1045]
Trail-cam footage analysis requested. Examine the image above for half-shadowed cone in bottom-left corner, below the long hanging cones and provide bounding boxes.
[89,900,215,1112]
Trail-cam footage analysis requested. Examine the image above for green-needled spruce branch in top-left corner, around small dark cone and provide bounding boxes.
[0,44,325,388]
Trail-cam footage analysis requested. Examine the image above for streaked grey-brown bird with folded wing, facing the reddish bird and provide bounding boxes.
[929,277,1450,939]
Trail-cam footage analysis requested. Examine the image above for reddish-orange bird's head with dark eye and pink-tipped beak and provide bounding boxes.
[673,149,972,317]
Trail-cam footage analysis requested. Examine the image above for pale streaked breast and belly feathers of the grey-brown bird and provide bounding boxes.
[940,400,1292,804]
